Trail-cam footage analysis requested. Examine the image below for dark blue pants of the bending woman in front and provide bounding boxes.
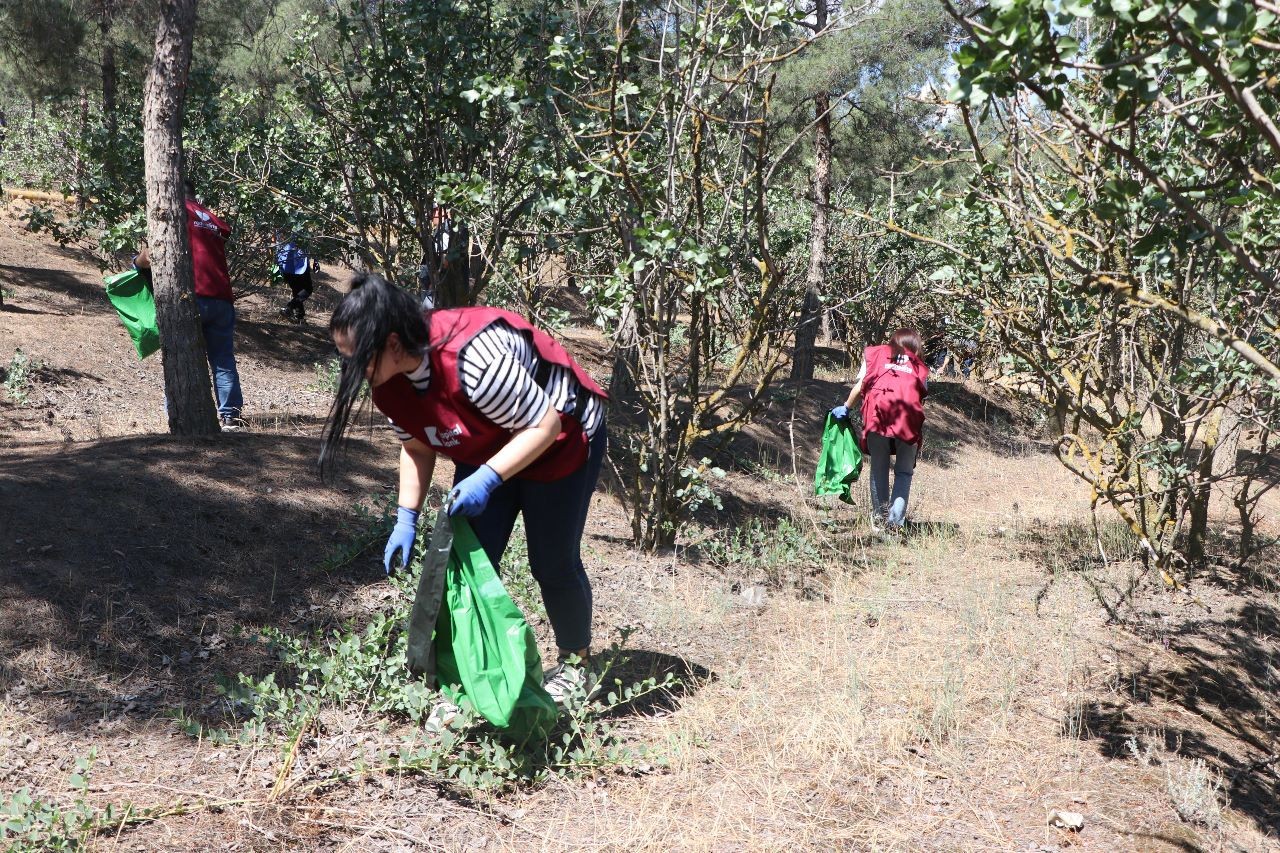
[453,424,609,652]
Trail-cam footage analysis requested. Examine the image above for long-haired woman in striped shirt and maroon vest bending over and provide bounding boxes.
[320,273,608,724]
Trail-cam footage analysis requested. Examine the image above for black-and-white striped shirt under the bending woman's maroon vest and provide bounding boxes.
[392,320,604,442]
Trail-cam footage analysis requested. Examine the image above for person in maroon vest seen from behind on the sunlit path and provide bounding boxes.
[831,329,929,534]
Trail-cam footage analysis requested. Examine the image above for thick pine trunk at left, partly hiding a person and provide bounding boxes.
[142,0,218,435]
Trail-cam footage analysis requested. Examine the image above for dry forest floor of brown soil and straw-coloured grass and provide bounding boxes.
[0,202,1280,850]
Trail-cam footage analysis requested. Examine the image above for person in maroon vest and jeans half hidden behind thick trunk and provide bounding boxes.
[133,178,244,433]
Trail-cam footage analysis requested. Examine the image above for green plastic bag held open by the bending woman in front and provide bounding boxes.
[435,517,558,740]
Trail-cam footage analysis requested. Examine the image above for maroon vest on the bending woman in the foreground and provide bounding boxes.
[374,307,608,482]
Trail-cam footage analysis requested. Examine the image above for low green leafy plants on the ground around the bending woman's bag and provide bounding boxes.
[193,507,677,789]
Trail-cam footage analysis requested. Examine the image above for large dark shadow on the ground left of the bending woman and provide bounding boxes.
[0,434,389,726]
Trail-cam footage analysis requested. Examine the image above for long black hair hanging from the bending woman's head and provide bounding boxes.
[319,273,429,479]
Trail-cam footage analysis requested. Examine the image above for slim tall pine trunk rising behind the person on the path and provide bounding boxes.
[791,0,831,379]
